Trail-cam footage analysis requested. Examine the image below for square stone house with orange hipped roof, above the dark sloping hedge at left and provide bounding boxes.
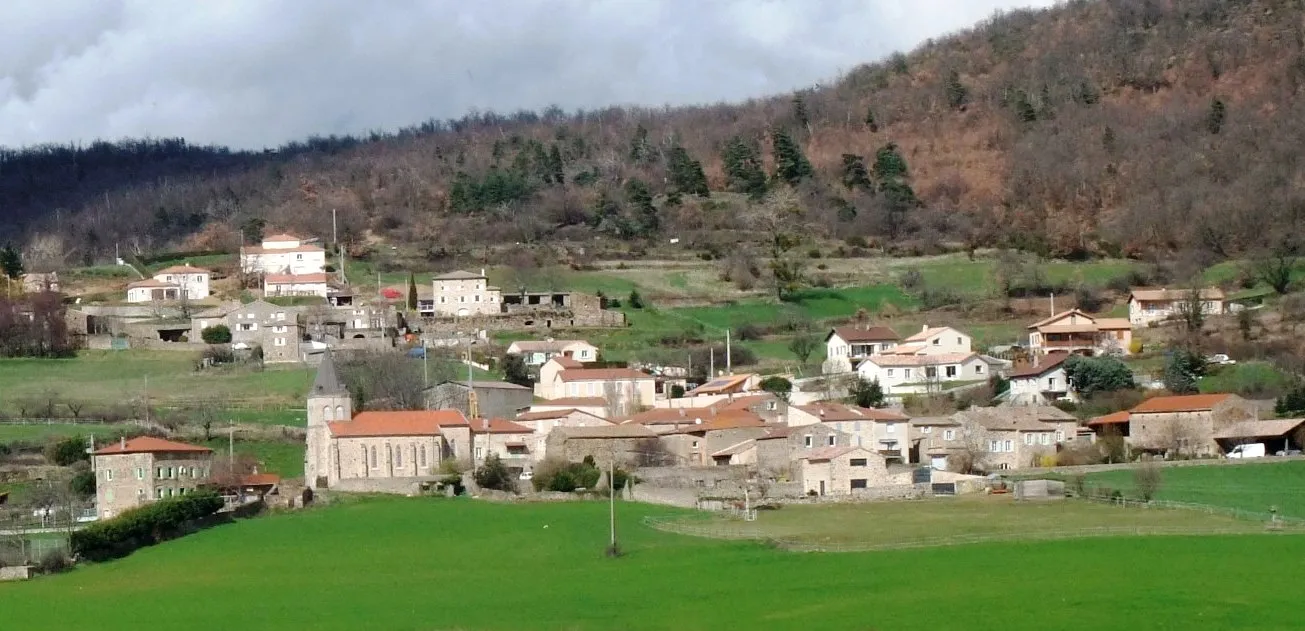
[91,435,213,519]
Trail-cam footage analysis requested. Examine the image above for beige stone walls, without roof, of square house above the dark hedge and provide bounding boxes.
[95,452,213,519]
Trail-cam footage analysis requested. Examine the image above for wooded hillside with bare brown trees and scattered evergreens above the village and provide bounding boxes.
[0,0,1305,265]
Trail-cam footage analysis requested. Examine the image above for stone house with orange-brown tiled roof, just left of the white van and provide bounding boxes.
[1128,394,1259,456]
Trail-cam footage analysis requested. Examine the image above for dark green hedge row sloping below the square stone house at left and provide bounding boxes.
[69,490,223,561]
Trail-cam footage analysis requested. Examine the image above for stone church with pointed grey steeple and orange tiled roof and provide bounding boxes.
[304,351,472,493]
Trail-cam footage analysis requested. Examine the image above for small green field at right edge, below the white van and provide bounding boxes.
[1087,460,1305,518]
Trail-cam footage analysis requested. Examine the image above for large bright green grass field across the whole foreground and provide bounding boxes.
[0,498,1305,631]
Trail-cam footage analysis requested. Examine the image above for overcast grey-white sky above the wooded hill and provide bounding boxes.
[0,0,1052,149]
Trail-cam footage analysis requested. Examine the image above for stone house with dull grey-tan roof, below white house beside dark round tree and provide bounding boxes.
[954,405,1078,471]
